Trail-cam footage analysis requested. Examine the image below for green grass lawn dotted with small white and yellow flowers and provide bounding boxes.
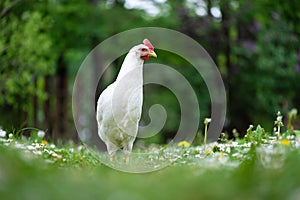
[0,122,300,200]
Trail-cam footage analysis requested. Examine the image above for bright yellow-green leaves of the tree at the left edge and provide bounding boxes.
[0,5,55,112]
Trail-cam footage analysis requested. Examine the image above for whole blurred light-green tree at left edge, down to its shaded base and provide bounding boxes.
[0,1,55,128]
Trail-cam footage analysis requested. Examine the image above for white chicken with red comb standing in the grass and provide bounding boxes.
[97,39,157,163]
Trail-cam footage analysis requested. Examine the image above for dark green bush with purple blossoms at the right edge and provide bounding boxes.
[230,1,300,128]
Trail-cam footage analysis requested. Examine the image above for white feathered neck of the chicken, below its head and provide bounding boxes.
[116,52,144,81]
